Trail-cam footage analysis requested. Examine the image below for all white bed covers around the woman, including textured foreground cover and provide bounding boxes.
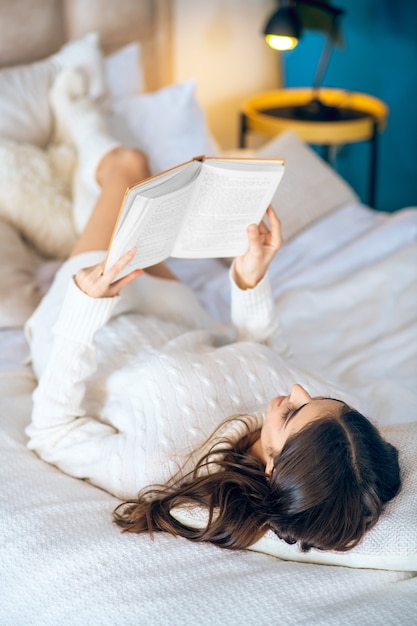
[0,205,417,626]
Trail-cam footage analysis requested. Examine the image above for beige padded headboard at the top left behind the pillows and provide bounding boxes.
[0,0,173,90]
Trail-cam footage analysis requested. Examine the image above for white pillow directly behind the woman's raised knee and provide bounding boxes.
[108,81,219,174]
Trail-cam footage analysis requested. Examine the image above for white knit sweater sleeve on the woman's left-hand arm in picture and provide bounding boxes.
[26,281,135,497]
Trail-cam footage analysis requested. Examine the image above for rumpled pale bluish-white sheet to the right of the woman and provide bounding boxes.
[170,204,417,425]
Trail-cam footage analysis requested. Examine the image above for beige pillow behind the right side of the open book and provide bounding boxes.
[254,131,358,241]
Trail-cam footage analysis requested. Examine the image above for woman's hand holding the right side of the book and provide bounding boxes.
[233,205,282,289]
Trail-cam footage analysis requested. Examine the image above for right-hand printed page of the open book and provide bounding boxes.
[172,161,284,258]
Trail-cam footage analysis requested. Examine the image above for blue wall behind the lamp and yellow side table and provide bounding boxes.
[283,0,417,211]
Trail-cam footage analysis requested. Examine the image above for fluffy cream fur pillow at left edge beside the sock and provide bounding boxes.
[0,139,76,258]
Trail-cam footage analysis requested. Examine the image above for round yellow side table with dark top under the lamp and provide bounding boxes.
[239,88,388,206]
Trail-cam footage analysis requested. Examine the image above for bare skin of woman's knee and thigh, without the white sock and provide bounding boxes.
[70,147,178,280]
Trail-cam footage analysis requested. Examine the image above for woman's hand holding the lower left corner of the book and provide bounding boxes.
[74,248,143,298]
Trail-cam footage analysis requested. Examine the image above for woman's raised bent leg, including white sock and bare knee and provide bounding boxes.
[50,70,176,279]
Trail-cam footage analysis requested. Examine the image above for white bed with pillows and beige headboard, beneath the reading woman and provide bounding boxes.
[0,0,417,626]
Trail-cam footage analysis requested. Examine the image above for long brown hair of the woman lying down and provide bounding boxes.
[114,405,401,551]
